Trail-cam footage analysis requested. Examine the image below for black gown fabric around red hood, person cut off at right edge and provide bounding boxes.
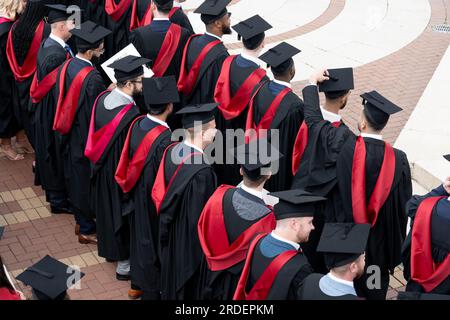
[402,186,450,295]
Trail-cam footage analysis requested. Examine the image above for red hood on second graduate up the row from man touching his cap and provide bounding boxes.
[214,56,266,120]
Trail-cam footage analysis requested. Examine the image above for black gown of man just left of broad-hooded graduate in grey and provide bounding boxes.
[159,143,217,300]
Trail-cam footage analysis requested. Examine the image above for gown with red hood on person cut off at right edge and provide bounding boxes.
[402,185,450,295]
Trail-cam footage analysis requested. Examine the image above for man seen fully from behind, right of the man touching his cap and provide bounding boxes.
[334,91,412,300]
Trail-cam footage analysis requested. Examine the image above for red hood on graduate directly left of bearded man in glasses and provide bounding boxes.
[53,59,94,134]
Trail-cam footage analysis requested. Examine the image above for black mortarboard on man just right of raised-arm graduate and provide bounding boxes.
[361,91,402,125]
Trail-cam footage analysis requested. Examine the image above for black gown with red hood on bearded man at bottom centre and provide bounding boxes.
[233,234,313,300]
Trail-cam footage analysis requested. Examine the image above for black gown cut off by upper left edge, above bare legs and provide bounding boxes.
[0,18,21,139]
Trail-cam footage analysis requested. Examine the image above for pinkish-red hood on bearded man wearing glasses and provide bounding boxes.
[84,91,134,164]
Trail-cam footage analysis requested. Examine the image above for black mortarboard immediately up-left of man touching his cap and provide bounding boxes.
[259,42,301,73]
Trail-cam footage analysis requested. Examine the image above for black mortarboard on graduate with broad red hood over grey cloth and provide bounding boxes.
[234,138,283,179]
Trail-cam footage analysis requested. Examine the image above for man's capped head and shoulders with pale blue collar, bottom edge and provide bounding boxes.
[299,223,370,300]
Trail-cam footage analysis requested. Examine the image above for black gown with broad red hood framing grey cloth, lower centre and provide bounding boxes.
[198,185,276,300]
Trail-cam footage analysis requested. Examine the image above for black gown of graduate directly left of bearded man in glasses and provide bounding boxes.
[55,58,106,218]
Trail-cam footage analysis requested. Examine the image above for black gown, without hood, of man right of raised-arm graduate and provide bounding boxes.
[338,137,412,299]
